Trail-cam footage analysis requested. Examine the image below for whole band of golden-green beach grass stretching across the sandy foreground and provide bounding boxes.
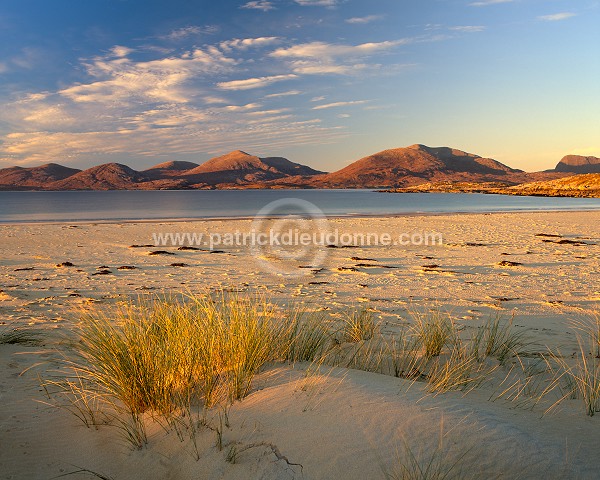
[43,292,600,454]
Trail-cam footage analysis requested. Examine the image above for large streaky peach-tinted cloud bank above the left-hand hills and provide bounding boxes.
[0,32,356,165]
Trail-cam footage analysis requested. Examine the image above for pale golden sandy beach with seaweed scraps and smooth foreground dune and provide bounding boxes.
[0,212,600,479]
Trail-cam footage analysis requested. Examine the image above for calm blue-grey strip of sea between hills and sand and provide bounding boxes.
[0,190,600,223]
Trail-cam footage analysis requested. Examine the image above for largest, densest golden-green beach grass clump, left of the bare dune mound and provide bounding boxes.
[44,293,330,447]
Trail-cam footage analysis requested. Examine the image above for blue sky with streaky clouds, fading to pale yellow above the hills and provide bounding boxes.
[0,0,600,171]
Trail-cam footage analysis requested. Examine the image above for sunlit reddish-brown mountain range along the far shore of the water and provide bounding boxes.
[0,144,600,190]
